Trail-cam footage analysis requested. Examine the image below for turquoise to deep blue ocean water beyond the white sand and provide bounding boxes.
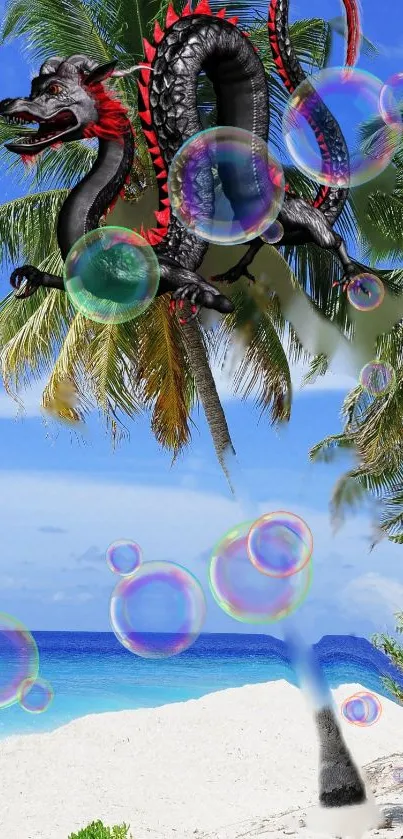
[0,632,403,738]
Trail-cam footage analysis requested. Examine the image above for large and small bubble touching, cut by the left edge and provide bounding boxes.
[0,612,54,714]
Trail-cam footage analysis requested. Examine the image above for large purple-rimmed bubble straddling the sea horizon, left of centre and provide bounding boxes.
[110,562,206,658]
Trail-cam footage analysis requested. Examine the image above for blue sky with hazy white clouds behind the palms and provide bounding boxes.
[0,0,403,640]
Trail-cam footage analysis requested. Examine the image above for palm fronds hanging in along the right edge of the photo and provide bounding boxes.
[310,148,403,546]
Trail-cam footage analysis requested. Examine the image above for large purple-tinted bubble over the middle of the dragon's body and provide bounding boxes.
[168,126,284,245]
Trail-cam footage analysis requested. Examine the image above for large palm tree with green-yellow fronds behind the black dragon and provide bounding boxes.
[0,0,403,488]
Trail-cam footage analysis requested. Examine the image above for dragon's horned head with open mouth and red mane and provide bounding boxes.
[0,55,135,157]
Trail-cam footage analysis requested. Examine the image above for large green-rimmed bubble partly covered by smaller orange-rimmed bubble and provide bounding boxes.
[209,521,312,623]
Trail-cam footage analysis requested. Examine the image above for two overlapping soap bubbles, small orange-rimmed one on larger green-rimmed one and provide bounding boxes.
[209,511,313,624]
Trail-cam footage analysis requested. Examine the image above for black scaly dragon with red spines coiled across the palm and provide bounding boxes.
[0,0,362,323]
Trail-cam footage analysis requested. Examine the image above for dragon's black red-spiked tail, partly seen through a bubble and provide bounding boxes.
[268,0,361,225]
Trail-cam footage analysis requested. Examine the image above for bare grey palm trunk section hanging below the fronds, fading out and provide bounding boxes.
[182,320,235,492]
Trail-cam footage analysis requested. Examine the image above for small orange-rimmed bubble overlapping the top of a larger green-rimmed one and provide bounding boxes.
[248,510,313,577]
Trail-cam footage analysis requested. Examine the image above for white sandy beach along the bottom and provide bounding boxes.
[0,681,403,839]
